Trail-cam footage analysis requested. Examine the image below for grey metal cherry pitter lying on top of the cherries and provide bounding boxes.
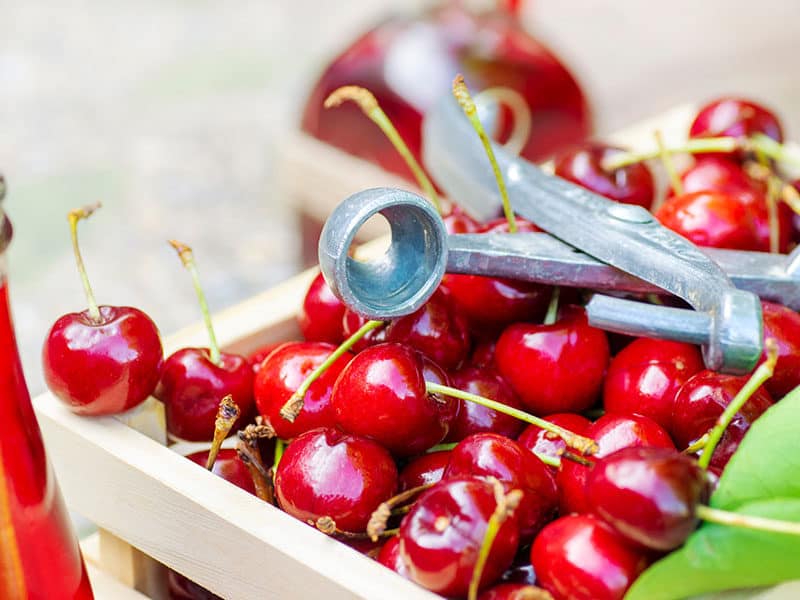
[319,91,800,374]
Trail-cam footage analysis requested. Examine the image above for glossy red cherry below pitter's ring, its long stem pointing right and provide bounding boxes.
[331,342,458,456]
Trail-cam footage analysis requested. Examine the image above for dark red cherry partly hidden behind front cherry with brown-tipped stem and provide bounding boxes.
[444,433,558,540]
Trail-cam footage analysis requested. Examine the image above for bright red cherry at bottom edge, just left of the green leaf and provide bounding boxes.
[531,515,647,600]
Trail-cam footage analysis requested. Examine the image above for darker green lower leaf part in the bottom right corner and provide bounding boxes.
[625,498,800,600]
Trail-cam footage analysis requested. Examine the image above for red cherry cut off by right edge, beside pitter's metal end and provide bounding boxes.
[761,301,800,399]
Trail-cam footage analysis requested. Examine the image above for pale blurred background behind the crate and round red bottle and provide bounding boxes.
[0,0,800,393]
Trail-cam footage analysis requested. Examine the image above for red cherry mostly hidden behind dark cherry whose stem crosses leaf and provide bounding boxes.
[556,413,675,515]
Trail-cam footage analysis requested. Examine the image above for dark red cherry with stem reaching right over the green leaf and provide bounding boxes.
[586,448,708,551]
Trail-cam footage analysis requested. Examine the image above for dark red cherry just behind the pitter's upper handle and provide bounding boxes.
[555,142,655,210]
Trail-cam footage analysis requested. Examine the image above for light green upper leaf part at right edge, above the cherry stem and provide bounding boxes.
[710,387,800,510]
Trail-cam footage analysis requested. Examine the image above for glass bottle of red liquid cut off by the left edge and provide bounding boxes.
[0,176,93,600]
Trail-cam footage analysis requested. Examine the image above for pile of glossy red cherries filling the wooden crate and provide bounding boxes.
[44,98,800,600]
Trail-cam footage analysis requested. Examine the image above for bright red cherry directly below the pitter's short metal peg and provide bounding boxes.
[603,338,705,429]
